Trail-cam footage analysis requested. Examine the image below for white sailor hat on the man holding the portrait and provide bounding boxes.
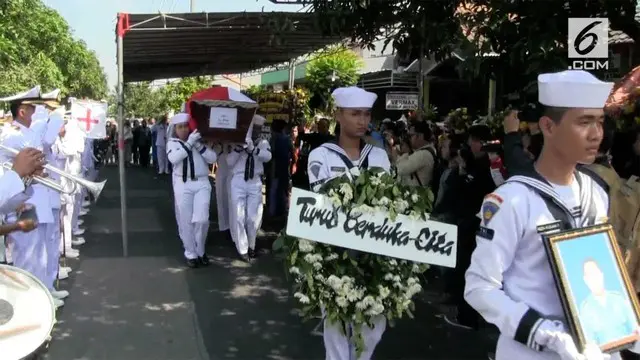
[538,70,613,109]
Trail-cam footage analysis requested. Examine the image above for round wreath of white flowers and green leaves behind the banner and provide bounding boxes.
[274,168,433,356]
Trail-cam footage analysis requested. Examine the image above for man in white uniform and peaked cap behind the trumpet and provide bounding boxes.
[0,86,68,306]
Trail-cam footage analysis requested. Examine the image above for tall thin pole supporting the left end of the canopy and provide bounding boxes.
[117,14,129,257]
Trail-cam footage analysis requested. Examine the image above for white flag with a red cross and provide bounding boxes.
[71,99,108,139]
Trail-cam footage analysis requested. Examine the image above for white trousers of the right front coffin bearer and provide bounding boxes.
[229,174,263,255]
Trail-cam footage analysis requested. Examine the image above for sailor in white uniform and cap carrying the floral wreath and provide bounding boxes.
[308,87,391,360]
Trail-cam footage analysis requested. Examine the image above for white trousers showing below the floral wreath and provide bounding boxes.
[322,316,387,360]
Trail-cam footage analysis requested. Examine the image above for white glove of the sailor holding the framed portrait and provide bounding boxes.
[534,320,611,360]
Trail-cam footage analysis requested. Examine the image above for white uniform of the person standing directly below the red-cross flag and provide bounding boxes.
[54,123,84,250]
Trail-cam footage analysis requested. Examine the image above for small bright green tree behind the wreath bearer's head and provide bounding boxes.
[305,47,363,109]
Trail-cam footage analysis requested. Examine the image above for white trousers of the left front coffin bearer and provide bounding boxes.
[173,176,211,259]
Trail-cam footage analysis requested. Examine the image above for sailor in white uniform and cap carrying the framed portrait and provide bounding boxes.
[465,70,636,360]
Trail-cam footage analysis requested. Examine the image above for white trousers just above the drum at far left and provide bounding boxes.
[10,223,53,285]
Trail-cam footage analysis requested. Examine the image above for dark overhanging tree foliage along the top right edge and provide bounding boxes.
[312,0,640,81]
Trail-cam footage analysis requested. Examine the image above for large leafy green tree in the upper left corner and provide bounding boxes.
[0,0,107,100]
